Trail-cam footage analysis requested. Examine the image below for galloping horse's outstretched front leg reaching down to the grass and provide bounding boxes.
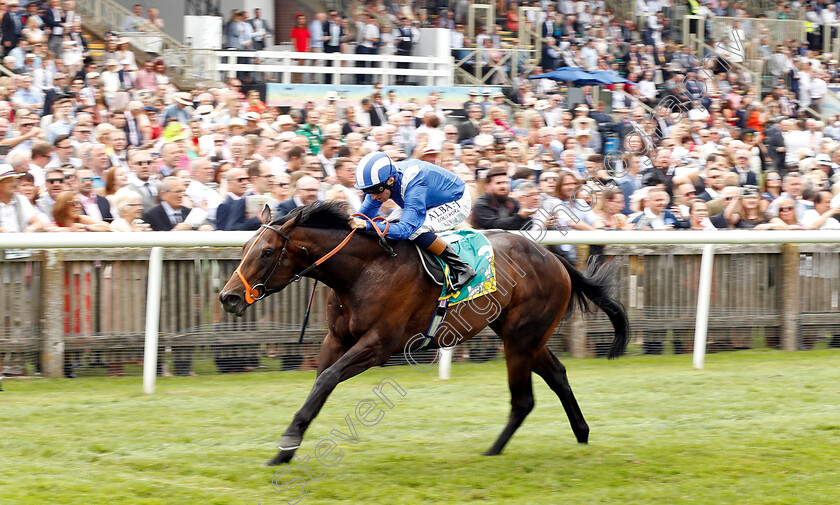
[268,332,396,465]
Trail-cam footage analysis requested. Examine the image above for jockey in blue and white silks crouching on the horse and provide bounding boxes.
[353,152,475,292]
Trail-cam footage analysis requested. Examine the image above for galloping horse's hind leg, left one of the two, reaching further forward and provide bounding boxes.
[484,341,534,456]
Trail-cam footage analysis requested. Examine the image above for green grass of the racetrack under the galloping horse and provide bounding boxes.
[0,350,840,505]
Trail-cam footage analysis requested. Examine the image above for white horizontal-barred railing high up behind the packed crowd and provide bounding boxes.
[216,50,453,86]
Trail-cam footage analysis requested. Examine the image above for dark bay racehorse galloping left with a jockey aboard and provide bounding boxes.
[219,202,629,465]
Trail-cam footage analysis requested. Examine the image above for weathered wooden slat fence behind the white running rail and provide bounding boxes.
[0,244,840,375]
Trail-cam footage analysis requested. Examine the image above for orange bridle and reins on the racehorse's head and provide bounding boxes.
[233,214,396,305]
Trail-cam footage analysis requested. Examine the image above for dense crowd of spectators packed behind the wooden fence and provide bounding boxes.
[0,0,840,244]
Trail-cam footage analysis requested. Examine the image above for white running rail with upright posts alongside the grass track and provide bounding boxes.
[0,230,840,394]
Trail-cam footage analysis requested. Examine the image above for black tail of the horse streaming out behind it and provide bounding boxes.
[557,255,630,359]
